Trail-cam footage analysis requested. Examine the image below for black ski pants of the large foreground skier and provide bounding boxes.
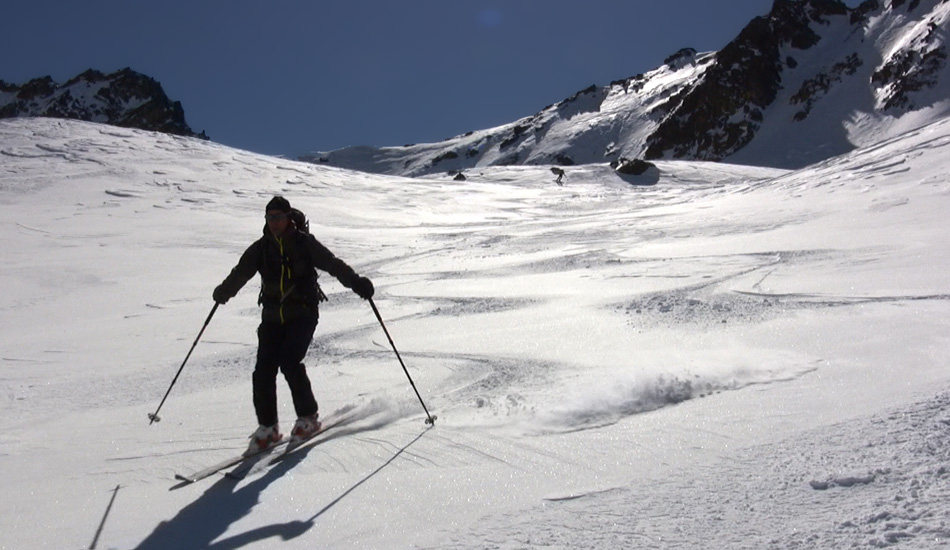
[253,316,317,432]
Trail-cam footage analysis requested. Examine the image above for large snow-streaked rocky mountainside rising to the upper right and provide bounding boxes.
[301,0,950,176]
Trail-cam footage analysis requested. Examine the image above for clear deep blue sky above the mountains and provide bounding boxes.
[0,0,812,156]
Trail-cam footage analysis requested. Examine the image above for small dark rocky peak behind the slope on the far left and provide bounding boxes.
[0,68,207,139]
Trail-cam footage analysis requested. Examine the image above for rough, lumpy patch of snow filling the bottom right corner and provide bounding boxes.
[431,392,950,549]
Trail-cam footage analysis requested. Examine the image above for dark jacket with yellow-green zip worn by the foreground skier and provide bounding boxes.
[215,226,358,324]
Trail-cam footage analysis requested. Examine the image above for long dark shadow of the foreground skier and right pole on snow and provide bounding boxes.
[136,428,428,550]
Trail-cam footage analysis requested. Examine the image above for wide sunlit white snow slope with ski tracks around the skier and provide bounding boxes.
[0,119,950,549]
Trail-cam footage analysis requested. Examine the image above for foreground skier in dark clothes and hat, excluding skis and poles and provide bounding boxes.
[213,196,374,452]
